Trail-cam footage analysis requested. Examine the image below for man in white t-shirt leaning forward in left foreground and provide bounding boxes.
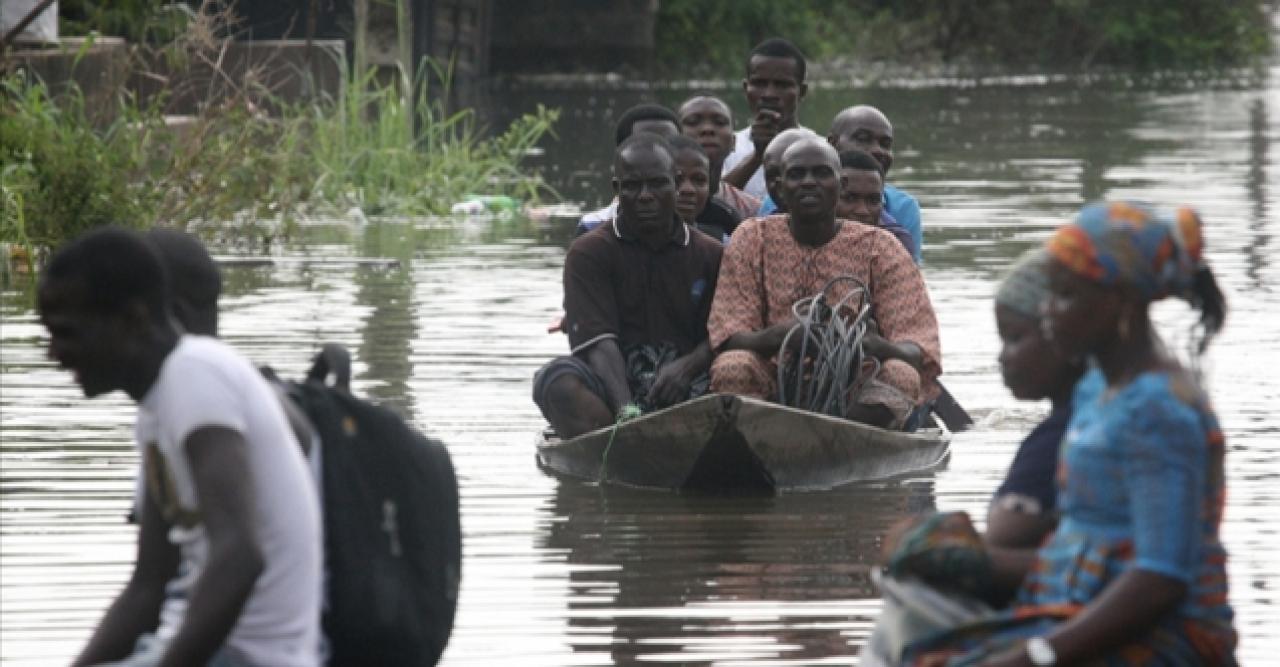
[38,228,321,667]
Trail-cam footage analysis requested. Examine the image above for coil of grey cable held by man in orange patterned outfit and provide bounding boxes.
[778,275,879,419]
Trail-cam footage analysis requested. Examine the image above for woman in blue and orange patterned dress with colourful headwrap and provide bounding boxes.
[904,204,1236,667]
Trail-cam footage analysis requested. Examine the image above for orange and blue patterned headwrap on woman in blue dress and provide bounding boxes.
[1047,202,1204,301]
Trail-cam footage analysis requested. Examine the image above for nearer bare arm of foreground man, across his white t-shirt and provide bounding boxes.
[160,426,264,667]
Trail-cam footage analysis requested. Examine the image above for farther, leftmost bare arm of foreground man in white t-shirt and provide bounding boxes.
[72,495,178,666]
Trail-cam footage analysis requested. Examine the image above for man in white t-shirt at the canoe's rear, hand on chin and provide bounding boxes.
[721,37,809,200]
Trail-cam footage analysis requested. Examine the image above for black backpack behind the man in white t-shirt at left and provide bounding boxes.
[276,343,462,667]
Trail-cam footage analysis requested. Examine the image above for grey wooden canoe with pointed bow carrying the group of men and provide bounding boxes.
[538,394,951,493]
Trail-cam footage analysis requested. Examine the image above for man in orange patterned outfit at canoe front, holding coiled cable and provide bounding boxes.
[708,138,942,430]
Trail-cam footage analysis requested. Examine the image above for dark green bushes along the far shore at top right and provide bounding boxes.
[655,0,1271,76]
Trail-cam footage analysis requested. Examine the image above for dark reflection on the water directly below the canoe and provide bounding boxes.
[535,474,934,664]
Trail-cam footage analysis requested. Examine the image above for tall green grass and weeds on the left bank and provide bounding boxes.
[0,3,558,256]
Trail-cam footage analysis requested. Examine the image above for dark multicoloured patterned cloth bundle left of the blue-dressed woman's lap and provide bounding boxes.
[884,512,992,598]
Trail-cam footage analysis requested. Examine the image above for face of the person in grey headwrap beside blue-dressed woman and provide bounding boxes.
[996,303,1080,401]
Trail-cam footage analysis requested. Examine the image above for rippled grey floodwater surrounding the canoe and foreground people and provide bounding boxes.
[0,59,1280,666]
